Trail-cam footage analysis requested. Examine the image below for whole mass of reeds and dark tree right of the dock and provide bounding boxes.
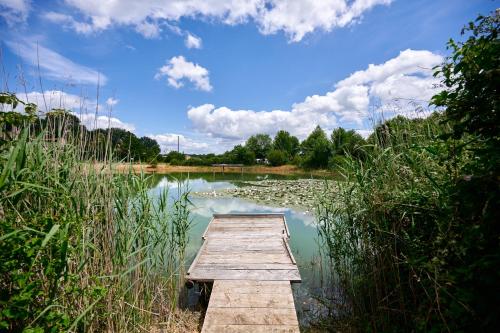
[318,12,500,332]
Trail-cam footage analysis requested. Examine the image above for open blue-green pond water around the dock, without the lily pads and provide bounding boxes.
[146,173,321,325]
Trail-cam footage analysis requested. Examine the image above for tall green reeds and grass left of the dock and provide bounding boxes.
[0,100,190,332]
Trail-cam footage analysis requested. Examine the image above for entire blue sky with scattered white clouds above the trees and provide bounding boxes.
[0,0,499,153]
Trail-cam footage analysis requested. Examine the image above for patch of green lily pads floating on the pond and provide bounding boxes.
[191,179,336,212]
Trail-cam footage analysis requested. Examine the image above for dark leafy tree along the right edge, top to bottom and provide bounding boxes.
[426,10,500,332]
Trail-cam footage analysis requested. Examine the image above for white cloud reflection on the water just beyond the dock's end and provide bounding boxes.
[191,198,315,226]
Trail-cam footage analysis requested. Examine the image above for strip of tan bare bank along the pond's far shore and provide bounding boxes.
[99,163,335,176]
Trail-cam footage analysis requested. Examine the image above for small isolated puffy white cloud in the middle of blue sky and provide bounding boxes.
[155,56,212,91]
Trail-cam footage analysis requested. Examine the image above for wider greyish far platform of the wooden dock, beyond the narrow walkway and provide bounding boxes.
[187,214,301,282]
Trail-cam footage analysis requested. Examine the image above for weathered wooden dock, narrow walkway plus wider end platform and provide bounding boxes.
[187,214,301,333]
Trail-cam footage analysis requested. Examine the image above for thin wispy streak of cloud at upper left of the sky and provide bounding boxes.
[6,38,107,85]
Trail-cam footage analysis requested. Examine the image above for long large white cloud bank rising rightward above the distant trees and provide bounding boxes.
[187,50,443,139]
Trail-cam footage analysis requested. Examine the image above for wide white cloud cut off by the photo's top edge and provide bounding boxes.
[43,0,392,42]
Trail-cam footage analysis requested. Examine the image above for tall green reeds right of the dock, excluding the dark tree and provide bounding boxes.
[318,114,468,332]
